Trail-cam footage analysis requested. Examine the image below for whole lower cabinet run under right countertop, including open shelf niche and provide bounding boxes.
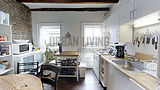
[100,58,146,90]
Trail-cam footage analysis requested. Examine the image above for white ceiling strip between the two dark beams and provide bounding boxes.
[23,3,113,9]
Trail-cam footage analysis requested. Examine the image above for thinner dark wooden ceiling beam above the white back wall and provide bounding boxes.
[31,8,110,11]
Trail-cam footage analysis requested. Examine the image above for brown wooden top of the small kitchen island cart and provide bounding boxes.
[55,51,79,56]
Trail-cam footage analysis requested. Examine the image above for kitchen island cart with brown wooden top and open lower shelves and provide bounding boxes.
[55,51,79,81]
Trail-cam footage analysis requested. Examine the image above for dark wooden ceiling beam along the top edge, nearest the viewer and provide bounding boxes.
[17,0,119,3]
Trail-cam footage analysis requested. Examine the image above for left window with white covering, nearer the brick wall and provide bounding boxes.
[40,24,61,47]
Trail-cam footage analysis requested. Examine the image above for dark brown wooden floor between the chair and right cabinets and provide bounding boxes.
[44,69,103,90]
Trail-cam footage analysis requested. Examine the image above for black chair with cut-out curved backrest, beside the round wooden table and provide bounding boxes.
[41,64,60,90]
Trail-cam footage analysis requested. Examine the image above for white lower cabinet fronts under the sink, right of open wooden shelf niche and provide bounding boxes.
[106,64,145,90]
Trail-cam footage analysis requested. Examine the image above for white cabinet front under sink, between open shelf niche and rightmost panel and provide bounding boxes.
[107,64,129,90]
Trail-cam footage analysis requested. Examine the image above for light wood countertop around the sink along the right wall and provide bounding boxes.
[101,54,159,90]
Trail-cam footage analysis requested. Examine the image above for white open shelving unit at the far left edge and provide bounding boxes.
[0,21,14,75]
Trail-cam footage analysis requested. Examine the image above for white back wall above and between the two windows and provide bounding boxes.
[32,11,106,50]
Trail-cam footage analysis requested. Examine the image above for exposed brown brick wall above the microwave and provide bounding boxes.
[0,0,32,40]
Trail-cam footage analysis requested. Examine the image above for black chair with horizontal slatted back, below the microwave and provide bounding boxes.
[17,62,39,76]
